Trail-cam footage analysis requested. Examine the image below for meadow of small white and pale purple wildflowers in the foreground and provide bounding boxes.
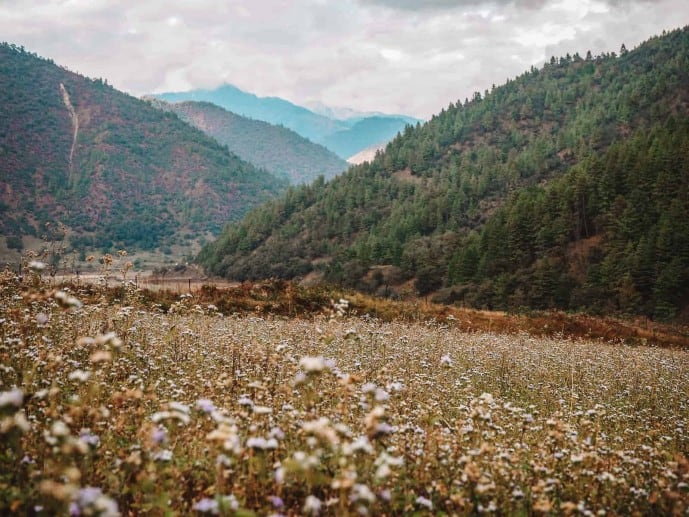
[0,272,689,515]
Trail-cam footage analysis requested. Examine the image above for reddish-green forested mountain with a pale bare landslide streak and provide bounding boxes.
[0,44,286,253]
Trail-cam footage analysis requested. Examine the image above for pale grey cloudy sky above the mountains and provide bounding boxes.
[0,0,689,118]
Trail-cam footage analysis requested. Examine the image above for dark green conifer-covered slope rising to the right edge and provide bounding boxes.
[200,28,689,319]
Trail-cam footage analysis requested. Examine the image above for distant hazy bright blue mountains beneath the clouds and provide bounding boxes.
[153,84,418,160]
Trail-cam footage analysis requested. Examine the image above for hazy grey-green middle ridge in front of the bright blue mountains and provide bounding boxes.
[151,98,349,184]
